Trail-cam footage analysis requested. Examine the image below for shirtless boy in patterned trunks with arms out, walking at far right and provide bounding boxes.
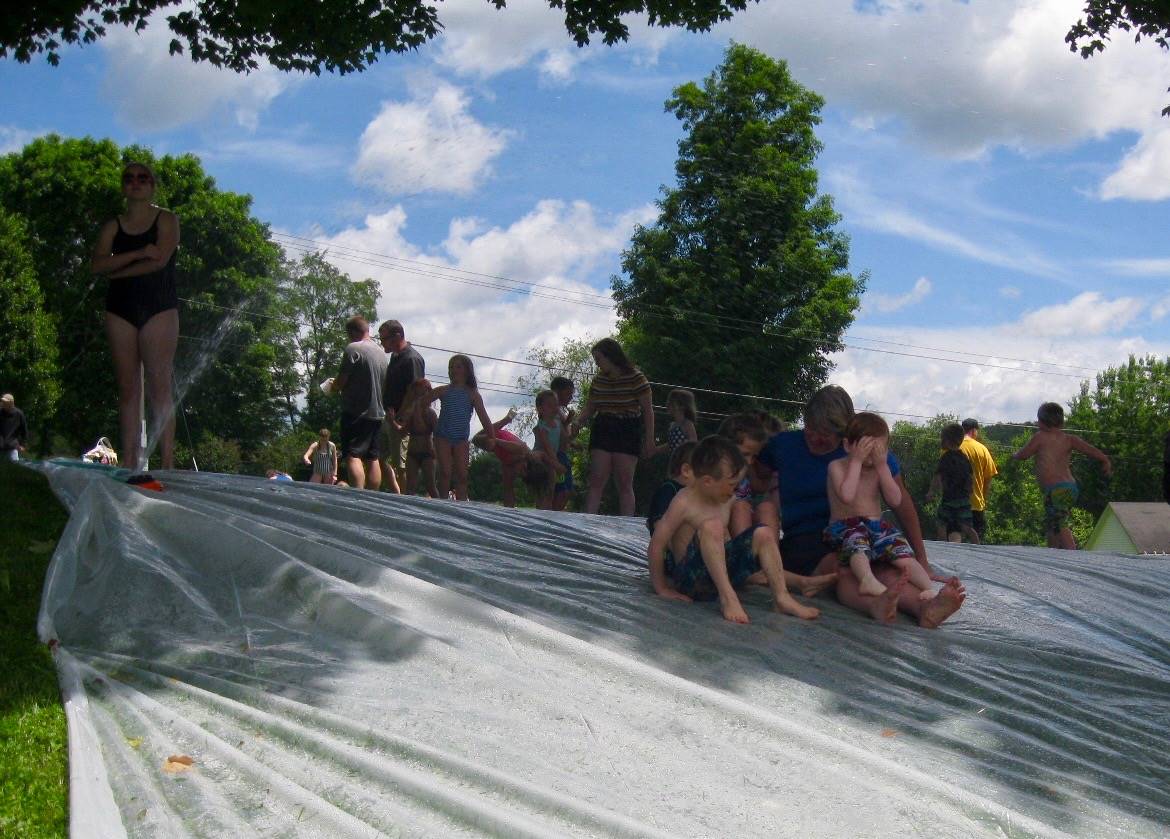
[1012,403,1113,550]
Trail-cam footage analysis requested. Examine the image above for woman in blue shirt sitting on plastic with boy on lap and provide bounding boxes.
[758,385,966,628]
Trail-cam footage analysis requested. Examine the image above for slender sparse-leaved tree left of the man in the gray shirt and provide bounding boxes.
[276,253,379,428]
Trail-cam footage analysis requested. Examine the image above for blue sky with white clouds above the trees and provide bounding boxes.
[0,0,1170,421]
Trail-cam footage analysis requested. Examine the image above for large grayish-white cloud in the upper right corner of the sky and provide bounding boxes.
[718,0,1170,200]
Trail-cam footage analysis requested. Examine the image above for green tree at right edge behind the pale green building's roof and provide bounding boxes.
[1065,356,1170,520]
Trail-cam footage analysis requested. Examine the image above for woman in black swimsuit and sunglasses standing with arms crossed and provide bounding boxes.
[91,163,179,469]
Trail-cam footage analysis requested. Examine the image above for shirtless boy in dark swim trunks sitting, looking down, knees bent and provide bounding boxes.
[647,435,820,624]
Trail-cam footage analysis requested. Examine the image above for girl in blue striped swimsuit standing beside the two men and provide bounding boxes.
[428,355,496,501]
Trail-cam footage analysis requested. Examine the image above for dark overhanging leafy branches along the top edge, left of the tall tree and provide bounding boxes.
[0,0,748,75]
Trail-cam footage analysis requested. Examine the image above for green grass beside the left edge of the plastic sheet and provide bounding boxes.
[0,463,68,837]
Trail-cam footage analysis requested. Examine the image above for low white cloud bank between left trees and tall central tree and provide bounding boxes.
[292,200,655,417]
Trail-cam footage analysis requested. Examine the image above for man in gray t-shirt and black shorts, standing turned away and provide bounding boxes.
[330,315,386,489]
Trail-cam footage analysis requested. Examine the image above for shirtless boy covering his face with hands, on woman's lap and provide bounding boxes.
[825,411,936,600]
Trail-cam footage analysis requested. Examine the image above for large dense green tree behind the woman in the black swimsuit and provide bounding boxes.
[0,135,290,461]
